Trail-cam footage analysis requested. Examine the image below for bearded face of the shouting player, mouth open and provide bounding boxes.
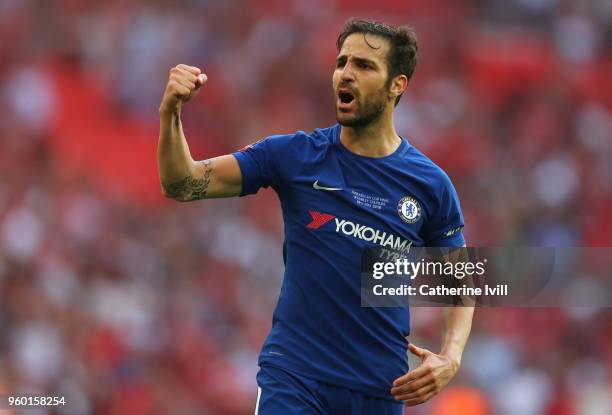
[332,33,390,127]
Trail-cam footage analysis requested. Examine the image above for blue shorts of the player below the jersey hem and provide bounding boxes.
[255,366,404,415]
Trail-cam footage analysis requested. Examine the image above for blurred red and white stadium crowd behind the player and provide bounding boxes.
[0,0,612,415]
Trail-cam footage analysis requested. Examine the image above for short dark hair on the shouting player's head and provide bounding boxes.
[336,19,419,105]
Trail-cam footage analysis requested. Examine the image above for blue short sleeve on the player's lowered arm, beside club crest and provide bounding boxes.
[423,173,465,247]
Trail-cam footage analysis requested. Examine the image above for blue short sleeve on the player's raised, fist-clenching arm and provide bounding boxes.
[233,135,293,196]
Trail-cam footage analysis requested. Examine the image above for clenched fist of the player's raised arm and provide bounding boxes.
[159,64,208,112]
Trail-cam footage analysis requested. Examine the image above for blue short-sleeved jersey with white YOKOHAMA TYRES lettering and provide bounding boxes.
[234,124,464,400]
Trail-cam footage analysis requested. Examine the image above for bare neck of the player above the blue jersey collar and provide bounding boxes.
[340,114,402,157]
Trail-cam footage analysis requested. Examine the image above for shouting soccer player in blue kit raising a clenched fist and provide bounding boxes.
[157,20,473,415]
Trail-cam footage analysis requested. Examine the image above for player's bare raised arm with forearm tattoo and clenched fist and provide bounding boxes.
[157,65,242,202]
